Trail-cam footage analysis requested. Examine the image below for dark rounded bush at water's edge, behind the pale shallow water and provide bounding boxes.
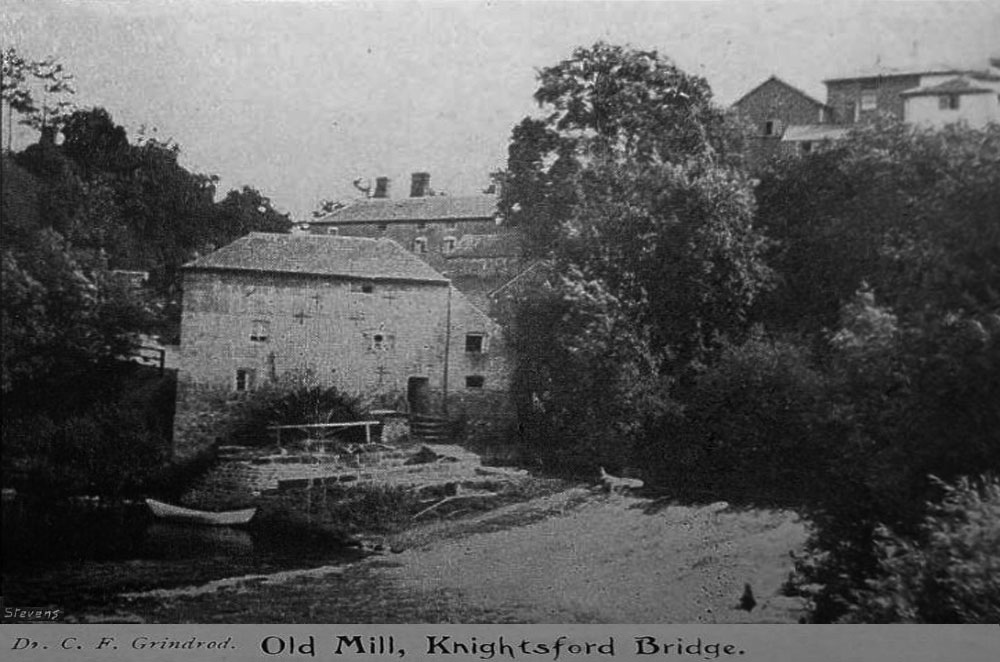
[643,330,839,498]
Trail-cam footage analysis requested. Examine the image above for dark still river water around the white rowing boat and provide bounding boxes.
[0,502,360,612]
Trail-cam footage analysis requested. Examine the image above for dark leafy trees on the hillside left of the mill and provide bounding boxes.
[0,99,290,392]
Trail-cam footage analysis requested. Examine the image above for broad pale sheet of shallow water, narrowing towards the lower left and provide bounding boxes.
[109,488,806,623]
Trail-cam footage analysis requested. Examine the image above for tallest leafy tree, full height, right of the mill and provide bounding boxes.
[500,42,769,468]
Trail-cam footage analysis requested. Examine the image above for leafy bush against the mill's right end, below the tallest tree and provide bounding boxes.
[513,272,668,472]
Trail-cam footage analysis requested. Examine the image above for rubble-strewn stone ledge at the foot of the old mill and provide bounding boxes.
[181,440,527,510]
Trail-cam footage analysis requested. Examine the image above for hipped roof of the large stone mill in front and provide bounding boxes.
[184,232,449,285]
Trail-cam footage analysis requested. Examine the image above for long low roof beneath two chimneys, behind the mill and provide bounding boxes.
[310,195,497,225]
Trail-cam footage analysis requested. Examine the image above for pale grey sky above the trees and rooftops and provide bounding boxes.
[0,0,1000,220]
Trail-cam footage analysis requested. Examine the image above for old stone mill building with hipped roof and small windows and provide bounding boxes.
[174,233,508,457]
